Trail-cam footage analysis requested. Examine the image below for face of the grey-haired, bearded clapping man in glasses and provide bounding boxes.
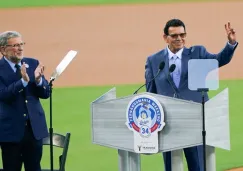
[1,37,25,63]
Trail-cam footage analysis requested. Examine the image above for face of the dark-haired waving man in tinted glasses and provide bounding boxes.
[164,26,186,53]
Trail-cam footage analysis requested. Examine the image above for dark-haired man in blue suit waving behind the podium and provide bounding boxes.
[145,19,238,171]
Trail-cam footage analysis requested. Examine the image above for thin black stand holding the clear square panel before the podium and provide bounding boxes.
[197,88,208,171]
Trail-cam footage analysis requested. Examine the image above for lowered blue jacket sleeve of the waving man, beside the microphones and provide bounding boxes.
[145,58,157,93]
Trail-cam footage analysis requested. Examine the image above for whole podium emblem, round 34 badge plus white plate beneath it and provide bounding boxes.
[126,95,165,153]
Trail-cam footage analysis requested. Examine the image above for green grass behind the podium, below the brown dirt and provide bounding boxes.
[0,80,243,171]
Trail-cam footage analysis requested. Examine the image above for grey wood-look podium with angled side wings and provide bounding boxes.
[91,88,230,171]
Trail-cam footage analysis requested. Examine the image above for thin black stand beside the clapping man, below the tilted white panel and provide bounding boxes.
[49,78,55,171]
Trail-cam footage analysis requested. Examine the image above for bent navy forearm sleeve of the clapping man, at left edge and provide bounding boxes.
[0,77,24,102]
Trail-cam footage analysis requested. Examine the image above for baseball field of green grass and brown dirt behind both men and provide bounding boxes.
[0,0,243,171]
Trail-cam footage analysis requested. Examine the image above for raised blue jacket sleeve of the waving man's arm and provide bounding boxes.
[200,43,238,67]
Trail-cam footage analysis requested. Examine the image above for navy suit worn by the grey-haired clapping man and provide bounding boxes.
[0,57,49,171]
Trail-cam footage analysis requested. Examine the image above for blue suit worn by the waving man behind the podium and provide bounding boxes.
[145,43,238,171]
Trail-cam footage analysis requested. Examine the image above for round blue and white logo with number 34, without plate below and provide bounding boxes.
[126,95,165,138]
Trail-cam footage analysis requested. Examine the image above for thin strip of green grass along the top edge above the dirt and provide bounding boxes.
[0,0,232,8]
